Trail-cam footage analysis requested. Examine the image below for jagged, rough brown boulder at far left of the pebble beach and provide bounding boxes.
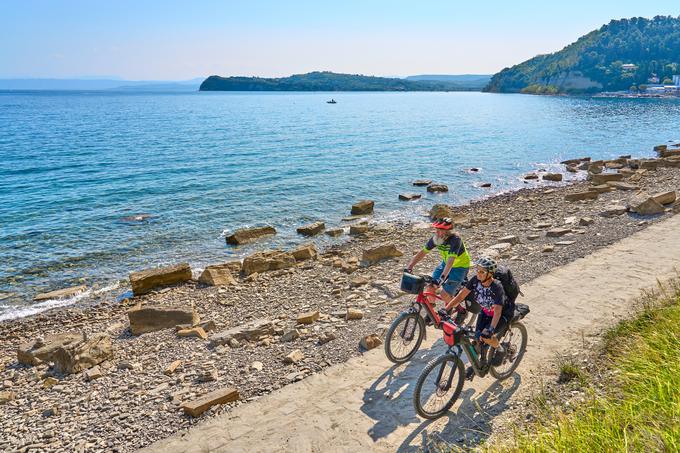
[53,333,113,374]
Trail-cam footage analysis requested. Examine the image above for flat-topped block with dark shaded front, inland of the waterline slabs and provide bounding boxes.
[128,305,201,335]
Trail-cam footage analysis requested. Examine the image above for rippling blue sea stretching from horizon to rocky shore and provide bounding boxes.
[0,92,680,319]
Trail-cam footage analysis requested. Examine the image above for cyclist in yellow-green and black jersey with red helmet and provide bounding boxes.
[405,218,470,304]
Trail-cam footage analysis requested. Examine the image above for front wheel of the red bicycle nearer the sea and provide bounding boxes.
[385,312,425,363]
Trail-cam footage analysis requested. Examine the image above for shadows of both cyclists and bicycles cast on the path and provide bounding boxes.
[361,339,521,452]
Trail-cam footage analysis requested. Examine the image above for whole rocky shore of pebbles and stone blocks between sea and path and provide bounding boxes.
[0,148,680,451]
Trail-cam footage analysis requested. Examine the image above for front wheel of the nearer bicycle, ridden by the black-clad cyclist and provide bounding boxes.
[413,353,465,419]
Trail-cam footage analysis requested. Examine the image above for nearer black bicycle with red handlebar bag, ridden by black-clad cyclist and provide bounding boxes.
[413,304,529,419]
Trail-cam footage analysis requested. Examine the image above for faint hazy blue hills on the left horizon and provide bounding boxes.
[0,79,203,91]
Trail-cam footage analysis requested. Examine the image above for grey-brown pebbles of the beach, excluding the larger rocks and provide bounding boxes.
[0,154,680,451]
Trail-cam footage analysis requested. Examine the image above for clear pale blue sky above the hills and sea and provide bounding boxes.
[0,0,680,80]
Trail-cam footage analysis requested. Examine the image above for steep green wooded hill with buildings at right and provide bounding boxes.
[484,16,680,94]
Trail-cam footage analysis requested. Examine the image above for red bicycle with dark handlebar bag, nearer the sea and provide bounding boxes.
[385,271,467,363]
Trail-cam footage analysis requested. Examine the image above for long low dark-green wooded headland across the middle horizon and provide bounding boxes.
[200,71,480,91]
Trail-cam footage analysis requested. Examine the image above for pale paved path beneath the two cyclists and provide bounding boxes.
[144,212,680,453]
